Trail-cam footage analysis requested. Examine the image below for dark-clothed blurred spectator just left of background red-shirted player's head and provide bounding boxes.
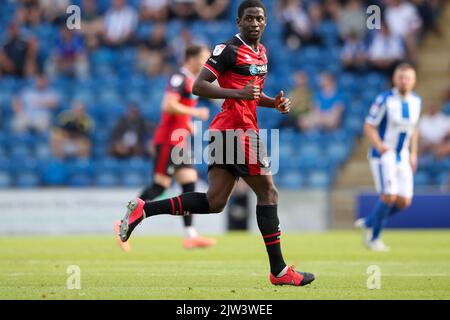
[138,23,171,76]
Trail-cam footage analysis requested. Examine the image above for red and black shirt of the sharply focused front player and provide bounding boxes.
[204,34,267,130]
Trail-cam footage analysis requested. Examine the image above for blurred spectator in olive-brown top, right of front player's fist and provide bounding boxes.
[279,71,313,129]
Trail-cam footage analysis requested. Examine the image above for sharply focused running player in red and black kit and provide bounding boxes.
[120,0,314,286]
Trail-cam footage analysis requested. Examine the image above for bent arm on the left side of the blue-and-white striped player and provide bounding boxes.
[364,96,390,155]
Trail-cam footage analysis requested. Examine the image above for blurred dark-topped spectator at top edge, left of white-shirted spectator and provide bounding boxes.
[80,0,103,49]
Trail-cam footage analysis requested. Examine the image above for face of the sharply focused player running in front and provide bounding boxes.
[237,7,266,41]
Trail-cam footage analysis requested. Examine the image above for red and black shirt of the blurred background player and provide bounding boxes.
[153,68,198,145]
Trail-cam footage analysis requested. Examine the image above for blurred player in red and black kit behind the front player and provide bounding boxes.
[115,45,215,251]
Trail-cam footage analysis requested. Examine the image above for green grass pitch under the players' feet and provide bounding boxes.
[0,230,450,300]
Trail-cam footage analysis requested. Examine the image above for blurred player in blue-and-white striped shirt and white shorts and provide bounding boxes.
[355,64,422,251]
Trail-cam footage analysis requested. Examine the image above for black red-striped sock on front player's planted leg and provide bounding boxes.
[256,205,286,277]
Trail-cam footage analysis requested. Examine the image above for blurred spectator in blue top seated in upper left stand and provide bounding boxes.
[47,26,89,79]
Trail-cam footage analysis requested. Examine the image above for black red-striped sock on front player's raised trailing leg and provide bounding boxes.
[144,192,210,217]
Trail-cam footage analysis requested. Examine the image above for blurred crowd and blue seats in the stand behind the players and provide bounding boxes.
[0,0,450,188]
